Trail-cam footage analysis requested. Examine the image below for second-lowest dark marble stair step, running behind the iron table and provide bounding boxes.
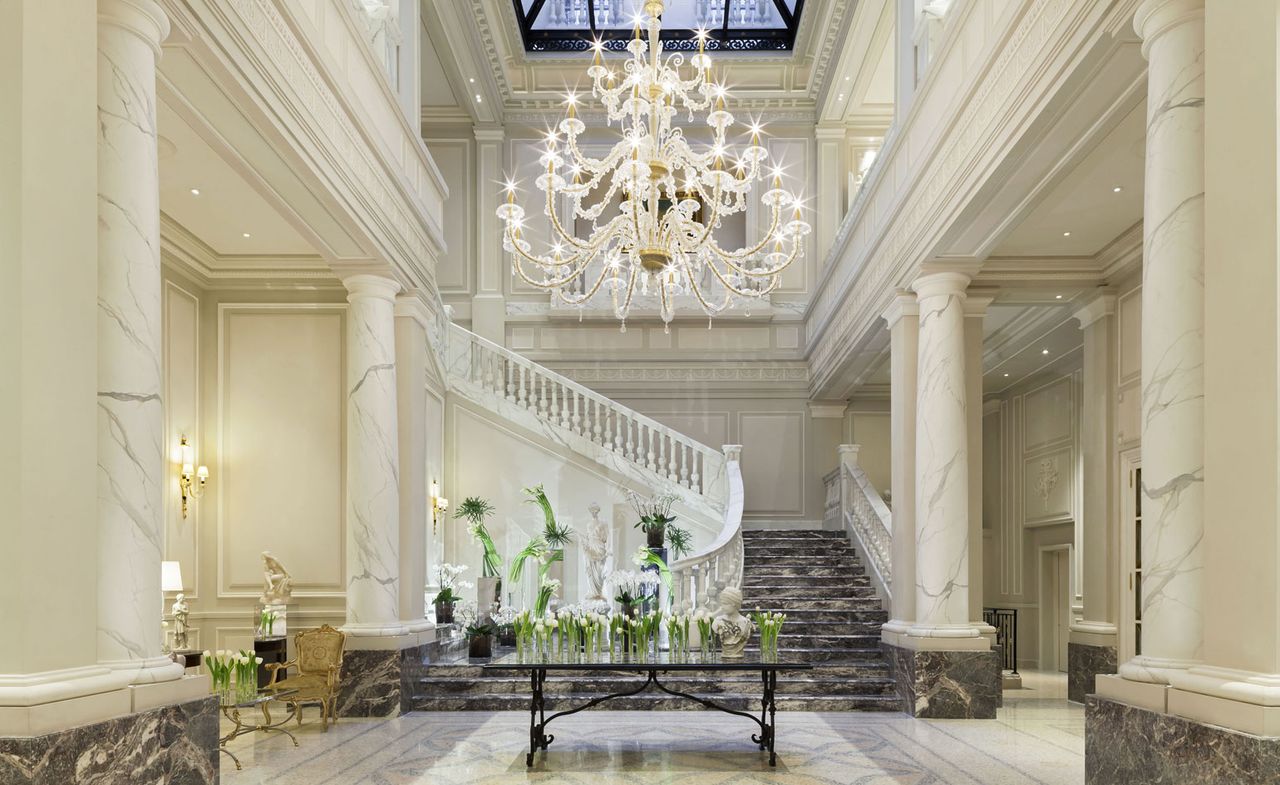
[417,672,893,697]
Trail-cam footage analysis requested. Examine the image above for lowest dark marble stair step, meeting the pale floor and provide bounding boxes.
[413,680,901,712]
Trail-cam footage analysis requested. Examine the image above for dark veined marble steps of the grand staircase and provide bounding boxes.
[412,530,899,711]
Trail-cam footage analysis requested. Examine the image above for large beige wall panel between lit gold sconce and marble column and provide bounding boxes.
[216,306,346,595]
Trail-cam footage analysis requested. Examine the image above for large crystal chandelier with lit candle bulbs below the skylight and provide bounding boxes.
[498,0,810,332]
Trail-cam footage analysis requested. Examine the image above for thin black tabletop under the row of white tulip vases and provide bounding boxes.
[484,652,813,672]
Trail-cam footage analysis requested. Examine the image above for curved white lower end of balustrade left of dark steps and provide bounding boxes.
[671,444,745,612]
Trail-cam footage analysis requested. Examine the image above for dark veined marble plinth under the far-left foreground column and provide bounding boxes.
[0,697,219,785]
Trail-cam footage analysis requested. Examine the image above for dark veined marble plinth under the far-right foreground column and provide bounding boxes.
[1084,695,1280,785]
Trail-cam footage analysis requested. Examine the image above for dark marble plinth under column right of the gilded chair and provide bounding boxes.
[338,644,430,717]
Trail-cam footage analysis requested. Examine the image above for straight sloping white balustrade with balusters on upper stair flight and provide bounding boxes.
[447,323,724,510]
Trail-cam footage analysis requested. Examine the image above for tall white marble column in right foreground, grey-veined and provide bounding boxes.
[1120,0,1204,683]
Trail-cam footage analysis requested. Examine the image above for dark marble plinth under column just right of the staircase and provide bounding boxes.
[881,643,1002,720]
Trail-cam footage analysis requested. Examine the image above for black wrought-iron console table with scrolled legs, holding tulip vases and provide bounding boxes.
[484,652,813,766]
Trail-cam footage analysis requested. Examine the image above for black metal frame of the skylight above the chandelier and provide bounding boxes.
[512,0,804,53]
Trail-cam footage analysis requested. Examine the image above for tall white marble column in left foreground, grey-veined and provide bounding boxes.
[97,0,182,683]
